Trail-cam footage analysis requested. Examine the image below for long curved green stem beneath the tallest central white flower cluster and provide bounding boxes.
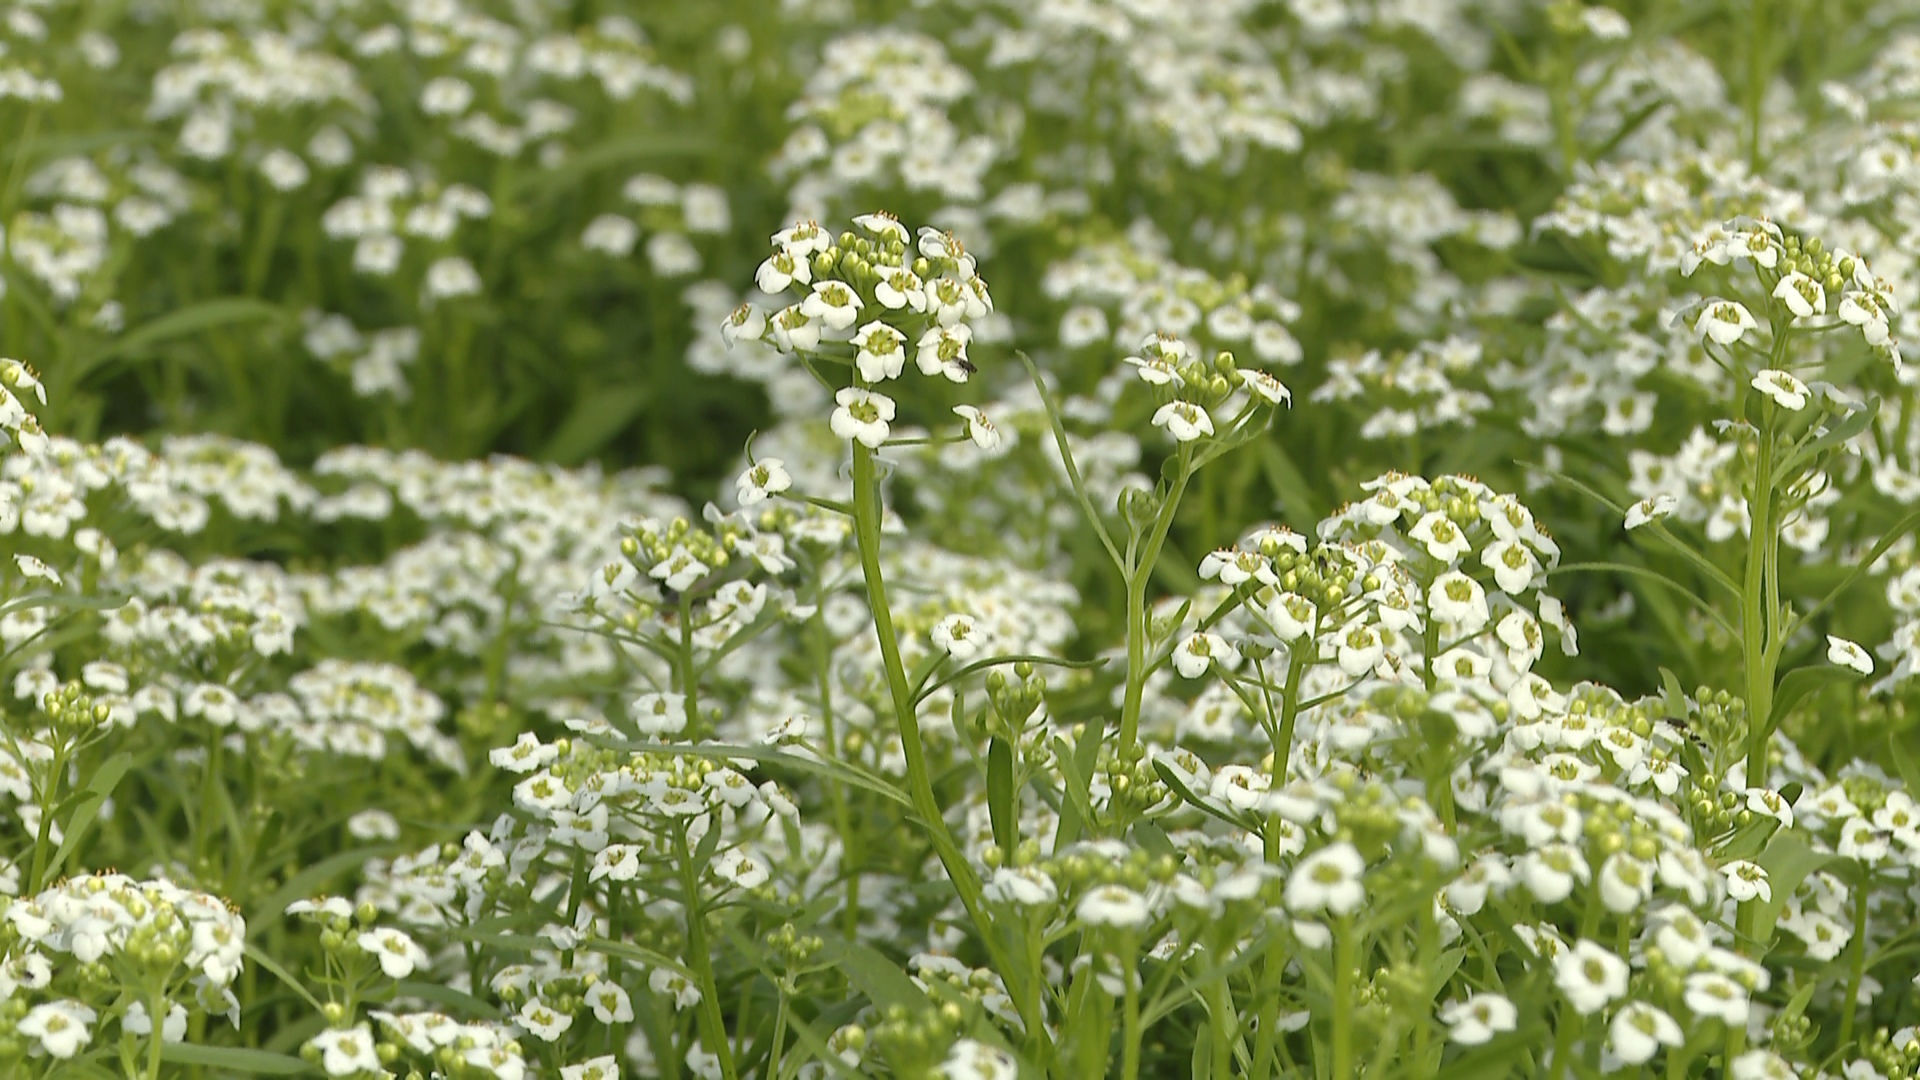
[852,442,1046,1047]
